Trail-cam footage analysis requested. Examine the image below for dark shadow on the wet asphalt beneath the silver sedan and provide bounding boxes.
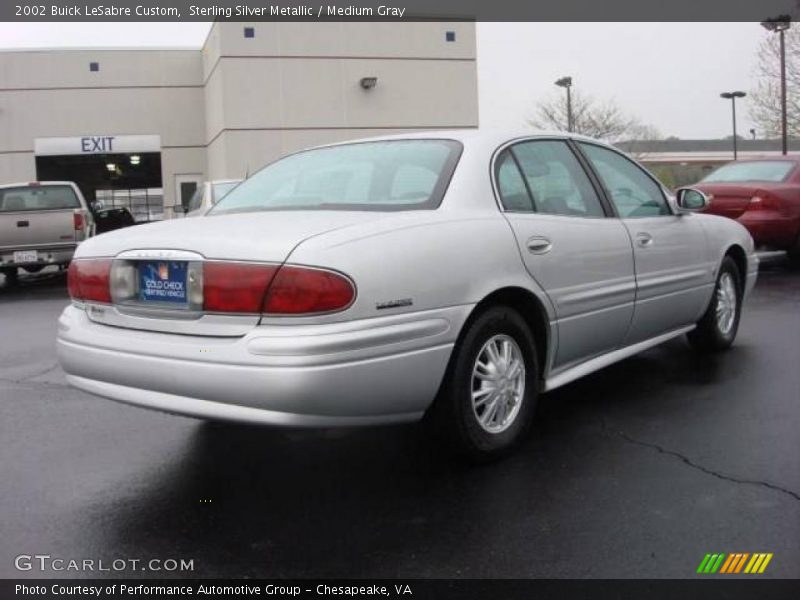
[87,341,746,577]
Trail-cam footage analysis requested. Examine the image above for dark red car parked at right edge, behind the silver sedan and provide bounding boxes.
[693,156,800,262]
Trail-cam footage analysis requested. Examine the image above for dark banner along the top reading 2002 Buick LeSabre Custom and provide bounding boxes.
[0,0,800,22]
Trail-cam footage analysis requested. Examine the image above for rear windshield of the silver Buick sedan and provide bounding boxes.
[211,140,461,214]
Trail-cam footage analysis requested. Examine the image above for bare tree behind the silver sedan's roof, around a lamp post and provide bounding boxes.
[528,91,661,143]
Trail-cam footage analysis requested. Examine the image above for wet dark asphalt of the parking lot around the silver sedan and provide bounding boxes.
[0,261,800,578]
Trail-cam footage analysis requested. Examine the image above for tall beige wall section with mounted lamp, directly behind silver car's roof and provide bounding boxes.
[203,22,478,179]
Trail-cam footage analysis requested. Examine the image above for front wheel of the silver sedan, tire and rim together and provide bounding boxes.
[687,256,743,352]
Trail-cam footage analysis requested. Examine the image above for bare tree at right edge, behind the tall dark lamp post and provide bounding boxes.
[749,26,800,137]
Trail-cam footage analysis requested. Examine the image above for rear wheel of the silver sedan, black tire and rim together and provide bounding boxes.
[431,306,539,462]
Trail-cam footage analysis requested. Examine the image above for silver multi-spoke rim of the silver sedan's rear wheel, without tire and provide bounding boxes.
[471,334,525,433]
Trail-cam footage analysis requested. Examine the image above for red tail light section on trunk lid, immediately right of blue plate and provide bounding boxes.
[203,262,278,313]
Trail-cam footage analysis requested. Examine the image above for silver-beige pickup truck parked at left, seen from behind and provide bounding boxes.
[0,181,94,284]
